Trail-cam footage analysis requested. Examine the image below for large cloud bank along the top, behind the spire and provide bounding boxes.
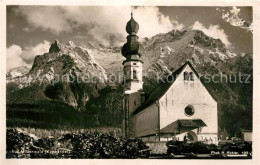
[17,6,184,45]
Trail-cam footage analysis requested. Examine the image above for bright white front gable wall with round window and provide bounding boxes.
[159,65,218,136]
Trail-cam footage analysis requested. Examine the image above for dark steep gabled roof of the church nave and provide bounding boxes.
[134,61,214,114]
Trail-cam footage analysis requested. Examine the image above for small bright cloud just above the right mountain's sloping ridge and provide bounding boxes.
[192,21,231,47]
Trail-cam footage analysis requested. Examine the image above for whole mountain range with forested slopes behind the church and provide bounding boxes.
[6,30,253,135]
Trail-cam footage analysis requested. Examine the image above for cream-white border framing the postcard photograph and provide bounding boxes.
[0,0,260,165]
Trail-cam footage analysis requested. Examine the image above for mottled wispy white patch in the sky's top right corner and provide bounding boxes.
[222,7,253,32]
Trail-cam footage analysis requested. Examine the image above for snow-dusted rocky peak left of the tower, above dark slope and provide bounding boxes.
[30,40,107,84]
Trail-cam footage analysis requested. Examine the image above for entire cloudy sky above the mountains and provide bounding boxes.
[6,6,253,71]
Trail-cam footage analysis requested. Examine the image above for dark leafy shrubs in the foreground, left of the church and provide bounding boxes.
[6,129,150,159]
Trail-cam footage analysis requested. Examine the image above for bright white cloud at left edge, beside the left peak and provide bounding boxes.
[7,41,50,71]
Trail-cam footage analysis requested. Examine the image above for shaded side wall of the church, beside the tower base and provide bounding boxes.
[135,103,158,137]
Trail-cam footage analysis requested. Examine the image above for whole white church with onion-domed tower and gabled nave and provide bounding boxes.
[121,13,218,144]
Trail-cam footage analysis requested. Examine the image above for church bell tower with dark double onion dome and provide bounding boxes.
[121,13,143,138]
